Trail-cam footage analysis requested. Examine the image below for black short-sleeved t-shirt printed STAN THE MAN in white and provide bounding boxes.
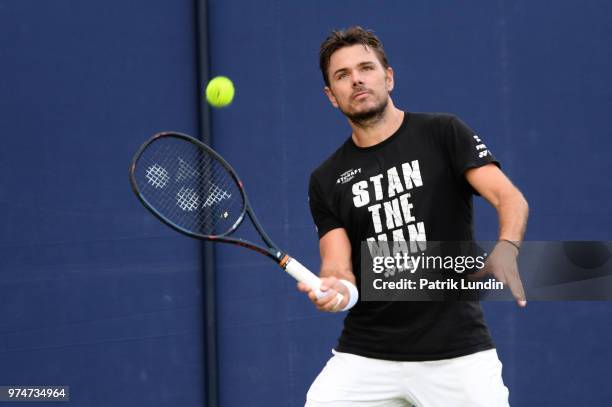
[309,112,498,361]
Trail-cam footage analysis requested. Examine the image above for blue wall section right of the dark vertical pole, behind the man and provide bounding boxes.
[211,1,612,406]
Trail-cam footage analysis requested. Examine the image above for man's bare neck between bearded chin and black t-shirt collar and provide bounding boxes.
[349,100,404,147]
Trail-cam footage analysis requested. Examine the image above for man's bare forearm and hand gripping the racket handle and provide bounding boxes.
[298,228,355,312]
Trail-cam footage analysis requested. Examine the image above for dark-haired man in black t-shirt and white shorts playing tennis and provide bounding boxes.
[298,27,528,407]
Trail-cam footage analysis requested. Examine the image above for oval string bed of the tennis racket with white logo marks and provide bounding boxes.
[135,137,244,236]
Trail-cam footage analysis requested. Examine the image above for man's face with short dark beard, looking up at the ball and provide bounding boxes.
[325,44,393,122]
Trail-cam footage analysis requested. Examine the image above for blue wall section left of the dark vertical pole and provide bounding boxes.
[0,0,204,406]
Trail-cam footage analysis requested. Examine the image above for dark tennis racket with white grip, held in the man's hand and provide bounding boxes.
[130,132,344,304]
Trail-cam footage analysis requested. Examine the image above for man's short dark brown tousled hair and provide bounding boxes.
[319,26,389,86]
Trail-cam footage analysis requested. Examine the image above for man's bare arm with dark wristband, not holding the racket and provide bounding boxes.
[465,164,529,307]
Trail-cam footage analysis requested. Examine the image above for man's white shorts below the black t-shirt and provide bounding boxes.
[306,349,509,407]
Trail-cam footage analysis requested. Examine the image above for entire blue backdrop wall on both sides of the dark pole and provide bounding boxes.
[0,0,612,406]
